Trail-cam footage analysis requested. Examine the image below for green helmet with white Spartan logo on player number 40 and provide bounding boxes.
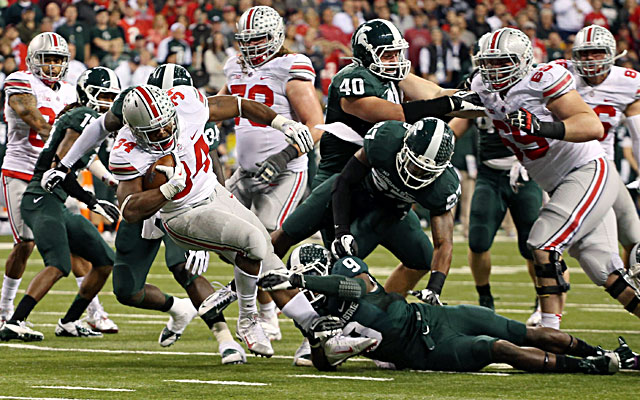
[351,19,411,81]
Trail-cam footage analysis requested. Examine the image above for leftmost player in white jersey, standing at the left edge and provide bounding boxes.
[0,32,117,331]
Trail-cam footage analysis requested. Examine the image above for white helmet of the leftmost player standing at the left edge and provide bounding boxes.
[26,32,71,83]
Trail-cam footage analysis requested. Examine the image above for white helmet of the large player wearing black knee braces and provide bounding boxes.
[476,28,533,92]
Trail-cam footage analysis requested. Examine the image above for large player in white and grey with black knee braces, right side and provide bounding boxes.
[471,28,640,328]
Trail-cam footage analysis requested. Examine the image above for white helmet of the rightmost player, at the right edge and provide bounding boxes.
[571,25,623,77]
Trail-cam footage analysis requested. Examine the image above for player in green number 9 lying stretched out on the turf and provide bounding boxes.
[258,245,631,374]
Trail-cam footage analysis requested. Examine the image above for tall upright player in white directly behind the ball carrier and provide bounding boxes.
[219,6,324,340]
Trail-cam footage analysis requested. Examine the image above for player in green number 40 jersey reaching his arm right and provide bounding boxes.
[272,19,482,300]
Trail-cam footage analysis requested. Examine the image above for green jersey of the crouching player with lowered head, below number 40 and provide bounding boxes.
[364,121,460,215]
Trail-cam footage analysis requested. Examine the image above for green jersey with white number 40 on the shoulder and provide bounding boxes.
[318,63,402,172]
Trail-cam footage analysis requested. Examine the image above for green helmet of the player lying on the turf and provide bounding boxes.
[287,243,332,304]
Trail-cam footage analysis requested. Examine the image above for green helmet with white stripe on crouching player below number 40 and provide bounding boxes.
[396,117,455,189]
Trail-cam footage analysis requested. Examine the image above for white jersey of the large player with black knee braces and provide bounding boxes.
[471,64,604,192]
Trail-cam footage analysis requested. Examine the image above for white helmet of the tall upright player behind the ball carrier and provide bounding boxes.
[236,6,284,68]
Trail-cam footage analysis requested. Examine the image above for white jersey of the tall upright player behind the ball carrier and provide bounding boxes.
[224,54,316,172]
